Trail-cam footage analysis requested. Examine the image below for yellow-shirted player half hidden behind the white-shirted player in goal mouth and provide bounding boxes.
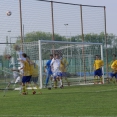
[60,57,70,86]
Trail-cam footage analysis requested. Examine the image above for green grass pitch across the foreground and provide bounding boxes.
[0,84,117,117]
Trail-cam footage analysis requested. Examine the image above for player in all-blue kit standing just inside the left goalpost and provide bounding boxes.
[46,54,53,87]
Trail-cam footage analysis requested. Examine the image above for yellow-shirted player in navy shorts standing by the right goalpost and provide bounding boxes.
[94,55,104,84]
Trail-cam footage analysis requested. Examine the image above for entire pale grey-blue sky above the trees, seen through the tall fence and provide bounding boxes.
[0,0,117,42]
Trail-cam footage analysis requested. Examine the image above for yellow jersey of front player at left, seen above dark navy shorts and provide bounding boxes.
[23,61,31,76]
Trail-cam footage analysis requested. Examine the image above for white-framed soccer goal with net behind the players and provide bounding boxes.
[20,40,104,88]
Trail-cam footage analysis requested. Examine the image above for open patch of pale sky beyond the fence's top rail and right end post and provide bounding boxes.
[55,0,117,35]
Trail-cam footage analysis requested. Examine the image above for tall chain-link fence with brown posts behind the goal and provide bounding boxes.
[0,0,117,86]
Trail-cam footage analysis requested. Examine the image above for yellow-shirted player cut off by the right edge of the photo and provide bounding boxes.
[109,54,117,82]
